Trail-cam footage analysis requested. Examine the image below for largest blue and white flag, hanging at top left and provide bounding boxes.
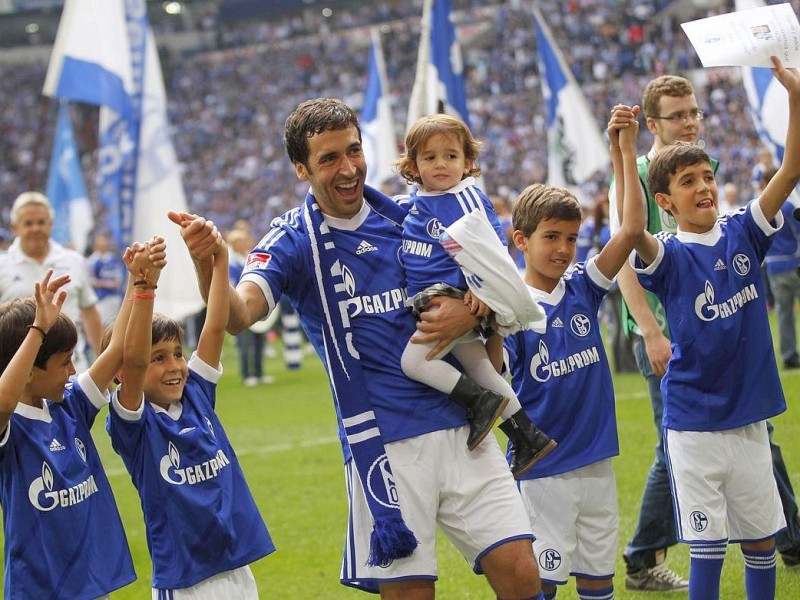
[44,0,203,319]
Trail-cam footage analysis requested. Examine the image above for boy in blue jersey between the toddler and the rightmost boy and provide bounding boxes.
[510,105,644,599]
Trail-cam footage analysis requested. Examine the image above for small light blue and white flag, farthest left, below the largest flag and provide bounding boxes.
[47,100,94,254]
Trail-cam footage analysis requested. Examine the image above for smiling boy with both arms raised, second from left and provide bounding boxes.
[108,241,275,600]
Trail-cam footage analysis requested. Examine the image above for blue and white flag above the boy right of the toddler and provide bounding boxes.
[533,5,611,198]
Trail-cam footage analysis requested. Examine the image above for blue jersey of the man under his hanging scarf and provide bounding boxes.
[242,197,465,446]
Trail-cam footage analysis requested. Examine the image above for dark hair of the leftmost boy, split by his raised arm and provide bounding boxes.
[0,297,78,373]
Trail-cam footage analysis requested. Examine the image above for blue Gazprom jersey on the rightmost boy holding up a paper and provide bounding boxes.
[634,201,786,431]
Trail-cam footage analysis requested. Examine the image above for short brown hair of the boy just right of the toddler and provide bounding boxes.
[511,183,582,237]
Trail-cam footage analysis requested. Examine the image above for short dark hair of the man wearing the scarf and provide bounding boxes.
[283,98,361,167]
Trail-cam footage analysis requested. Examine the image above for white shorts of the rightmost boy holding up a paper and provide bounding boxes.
[664,421,786,544]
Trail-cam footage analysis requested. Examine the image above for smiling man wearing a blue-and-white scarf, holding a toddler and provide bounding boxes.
[171,98,541,600]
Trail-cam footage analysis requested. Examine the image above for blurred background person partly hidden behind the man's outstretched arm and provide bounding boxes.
[228,229,274,387]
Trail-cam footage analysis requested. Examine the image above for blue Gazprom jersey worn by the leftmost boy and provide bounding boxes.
[0,373,136,600]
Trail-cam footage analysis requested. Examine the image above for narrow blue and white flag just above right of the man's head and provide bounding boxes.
[360,27,398,188]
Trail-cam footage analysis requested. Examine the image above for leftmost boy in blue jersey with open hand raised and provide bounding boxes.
[0,269,136,600]
